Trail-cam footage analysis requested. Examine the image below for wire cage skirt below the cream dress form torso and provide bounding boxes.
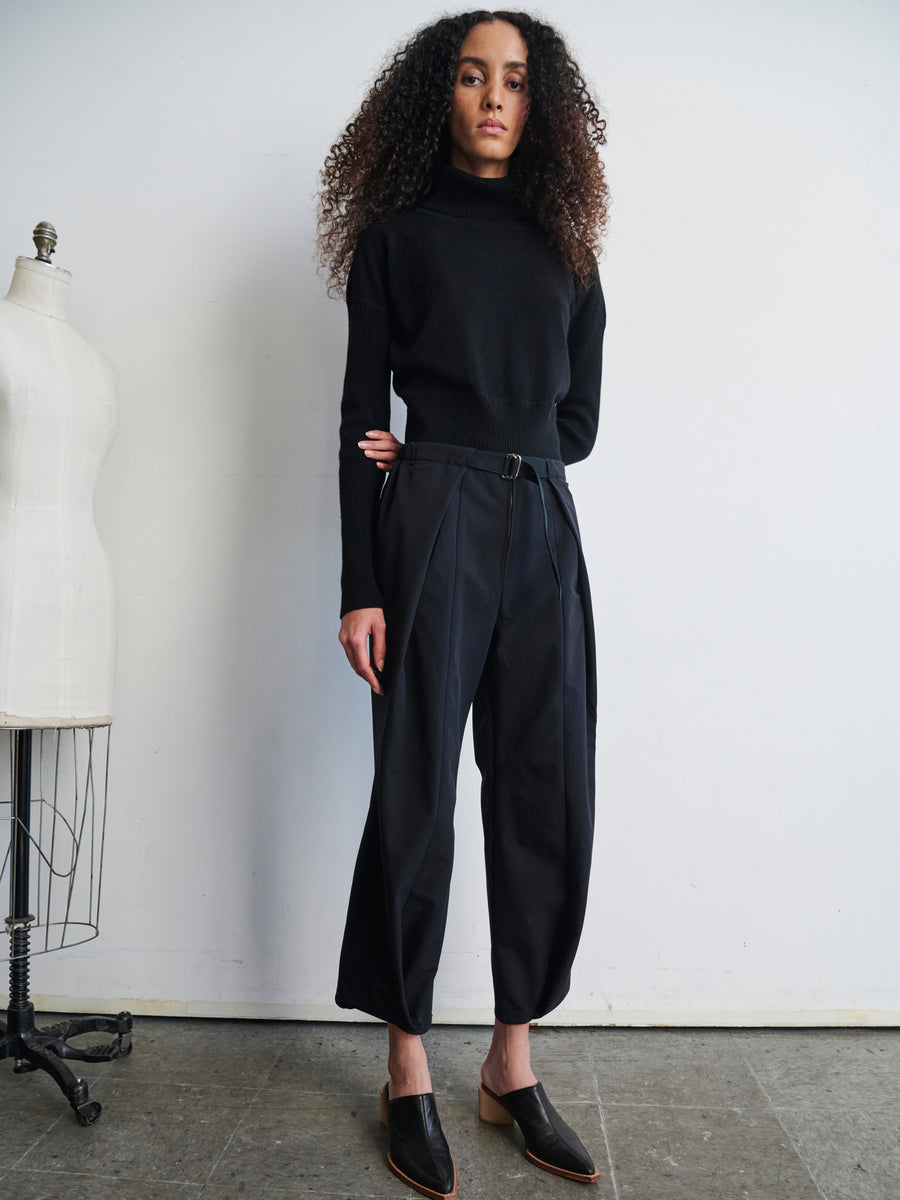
[0,725,112,961]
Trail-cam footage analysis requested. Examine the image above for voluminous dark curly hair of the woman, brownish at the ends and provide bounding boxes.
[318,11,608,295]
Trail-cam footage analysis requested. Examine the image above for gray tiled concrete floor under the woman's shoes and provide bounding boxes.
[0,1018,900,1200]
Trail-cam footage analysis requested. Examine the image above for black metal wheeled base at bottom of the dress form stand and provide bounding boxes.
[0,1003,132,1124]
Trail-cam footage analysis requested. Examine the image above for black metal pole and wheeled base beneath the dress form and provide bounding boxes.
[0,730,132,1126]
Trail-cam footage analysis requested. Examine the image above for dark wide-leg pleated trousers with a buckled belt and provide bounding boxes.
[336,442,596,1033]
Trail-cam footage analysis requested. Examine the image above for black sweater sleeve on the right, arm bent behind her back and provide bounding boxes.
[557,275,606,463]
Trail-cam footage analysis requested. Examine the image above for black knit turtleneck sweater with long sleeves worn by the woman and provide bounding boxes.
[340,167,606,616]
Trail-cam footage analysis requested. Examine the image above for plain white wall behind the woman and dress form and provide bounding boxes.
[0,0,900,1024]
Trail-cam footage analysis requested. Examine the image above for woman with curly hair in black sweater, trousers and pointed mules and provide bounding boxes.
[320,12,606,1198]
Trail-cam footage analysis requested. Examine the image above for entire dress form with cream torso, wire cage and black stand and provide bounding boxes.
[0,222,132,1126]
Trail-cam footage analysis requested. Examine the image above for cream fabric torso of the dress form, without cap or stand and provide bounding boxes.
[0,236,115,728]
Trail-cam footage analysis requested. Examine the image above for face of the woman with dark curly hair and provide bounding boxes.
[449,20,528,178]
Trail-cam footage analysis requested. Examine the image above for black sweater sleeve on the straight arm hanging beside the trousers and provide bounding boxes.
[338,228,391,617]
